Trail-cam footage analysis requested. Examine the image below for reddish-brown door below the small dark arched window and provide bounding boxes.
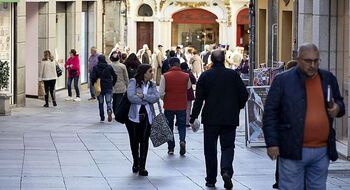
[137,22,153,50]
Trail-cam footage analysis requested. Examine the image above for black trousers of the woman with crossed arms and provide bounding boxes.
[126,114,151,169]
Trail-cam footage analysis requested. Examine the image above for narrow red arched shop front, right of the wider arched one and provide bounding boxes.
[236,8,249,51]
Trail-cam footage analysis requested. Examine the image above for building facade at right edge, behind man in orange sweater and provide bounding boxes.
[297,0,350,158]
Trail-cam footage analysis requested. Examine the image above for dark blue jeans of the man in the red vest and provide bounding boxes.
[164,110,186,149]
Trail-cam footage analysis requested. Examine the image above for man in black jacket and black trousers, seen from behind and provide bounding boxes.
[190,50,248,189]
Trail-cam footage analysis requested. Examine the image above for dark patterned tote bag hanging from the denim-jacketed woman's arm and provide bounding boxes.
[150,101,174,147]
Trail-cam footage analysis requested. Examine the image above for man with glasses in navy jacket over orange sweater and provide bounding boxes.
[263,44,345,190]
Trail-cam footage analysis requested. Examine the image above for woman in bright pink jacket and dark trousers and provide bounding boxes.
[64,49,80,102]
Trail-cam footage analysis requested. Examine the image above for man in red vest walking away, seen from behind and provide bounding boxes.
[159,57,192,156]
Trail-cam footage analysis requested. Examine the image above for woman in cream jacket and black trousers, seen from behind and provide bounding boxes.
[39,50,58,107]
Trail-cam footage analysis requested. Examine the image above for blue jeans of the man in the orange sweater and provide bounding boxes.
[279,147,329,190]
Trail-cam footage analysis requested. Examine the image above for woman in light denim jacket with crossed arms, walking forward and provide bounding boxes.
[126,64,159,176]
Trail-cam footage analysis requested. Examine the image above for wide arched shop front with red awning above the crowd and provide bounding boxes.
[171,9,219,51]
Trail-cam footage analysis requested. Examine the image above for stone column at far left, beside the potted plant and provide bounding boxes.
[14,1,26,106]
